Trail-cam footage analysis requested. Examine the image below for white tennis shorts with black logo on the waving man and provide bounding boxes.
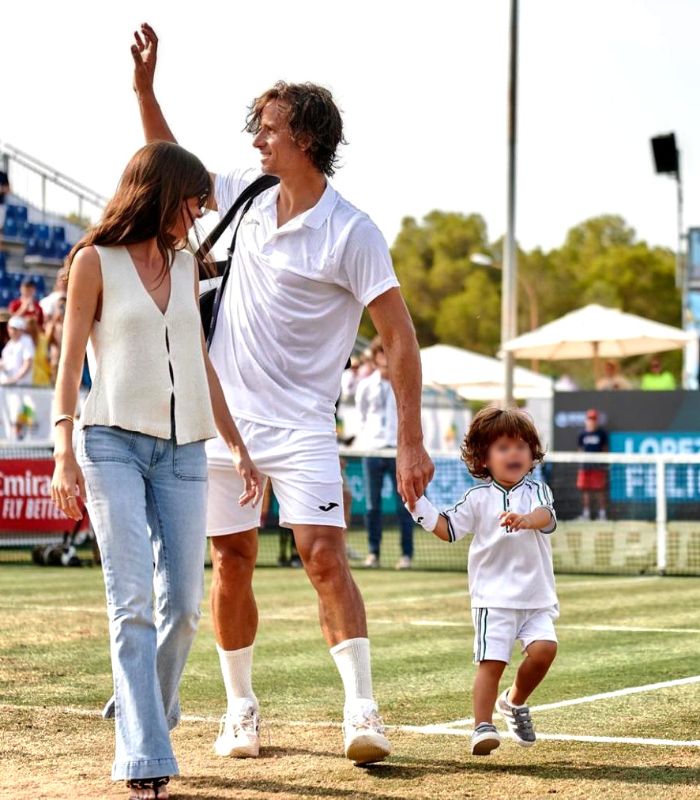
[207,420,345,536]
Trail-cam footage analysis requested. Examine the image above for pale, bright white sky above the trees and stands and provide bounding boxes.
[0,0,700,248]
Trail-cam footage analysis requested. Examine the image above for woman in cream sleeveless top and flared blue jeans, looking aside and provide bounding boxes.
[52,142,262,800]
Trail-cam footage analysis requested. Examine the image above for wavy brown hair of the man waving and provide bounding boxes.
[244,81,347,177]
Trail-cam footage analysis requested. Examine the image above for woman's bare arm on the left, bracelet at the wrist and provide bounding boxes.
[51,247,102,520]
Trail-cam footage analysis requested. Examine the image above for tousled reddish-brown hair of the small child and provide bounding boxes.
[460,406,544,478]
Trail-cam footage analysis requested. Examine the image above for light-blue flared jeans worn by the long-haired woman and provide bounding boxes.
[78,425,207,780]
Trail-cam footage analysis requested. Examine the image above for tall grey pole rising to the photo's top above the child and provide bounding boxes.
[501,0,518,406]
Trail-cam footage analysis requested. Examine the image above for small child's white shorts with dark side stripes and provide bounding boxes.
[472,605,559,664]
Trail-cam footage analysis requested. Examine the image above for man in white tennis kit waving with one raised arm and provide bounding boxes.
[132,25,433,764]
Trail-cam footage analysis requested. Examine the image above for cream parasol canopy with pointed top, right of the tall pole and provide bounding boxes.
[503,304,695,361]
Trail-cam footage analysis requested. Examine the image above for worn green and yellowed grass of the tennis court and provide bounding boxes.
[0,564,700,800]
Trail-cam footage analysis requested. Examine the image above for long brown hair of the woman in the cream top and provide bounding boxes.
[64,142,211,280]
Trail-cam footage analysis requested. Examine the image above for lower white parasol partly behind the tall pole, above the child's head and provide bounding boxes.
[420,344,552,400]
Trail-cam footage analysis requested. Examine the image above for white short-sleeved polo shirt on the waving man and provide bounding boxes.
[207,170,399,458]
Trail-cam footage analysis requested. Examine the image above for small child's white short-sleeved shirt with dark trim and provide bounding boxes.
[442,476,557,609]
